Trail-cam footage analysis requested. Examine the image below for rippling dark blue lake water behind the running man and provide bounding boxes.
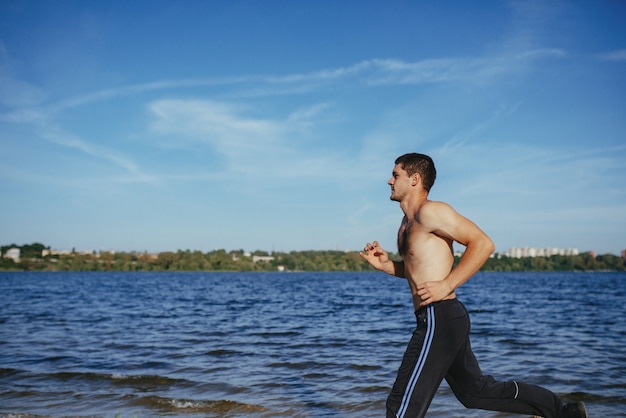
[0,273,626,418]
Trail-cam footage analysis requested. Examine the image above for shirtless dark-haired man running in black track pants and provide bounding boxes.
[360,154,587,418]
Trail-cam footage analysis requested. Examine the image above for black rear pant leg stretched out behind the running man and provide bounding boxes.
[446,304,563,418]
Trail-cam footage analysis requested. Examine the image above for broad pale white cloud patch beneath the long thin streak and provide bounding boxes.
[148,99,352,178]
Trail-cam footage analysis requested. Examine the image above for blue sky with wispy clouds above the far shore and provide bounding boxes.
[0,0,626,254]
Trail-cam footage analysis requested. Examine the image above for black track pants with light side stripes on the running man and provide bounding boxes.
[387,299,563,418]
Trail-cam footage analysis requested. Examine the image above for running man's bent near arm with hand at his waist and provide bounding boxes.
[417,202,495,306]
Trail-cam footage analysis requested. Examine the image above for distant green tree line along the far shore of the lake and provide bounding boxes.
[0,243,626,272]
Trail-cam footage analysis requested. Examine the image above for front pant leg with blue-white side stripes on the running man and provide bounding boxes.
[387,300,469,418]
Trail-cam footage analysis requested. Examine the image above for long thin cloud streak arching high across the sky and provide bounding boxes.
[31,48,568,111]
